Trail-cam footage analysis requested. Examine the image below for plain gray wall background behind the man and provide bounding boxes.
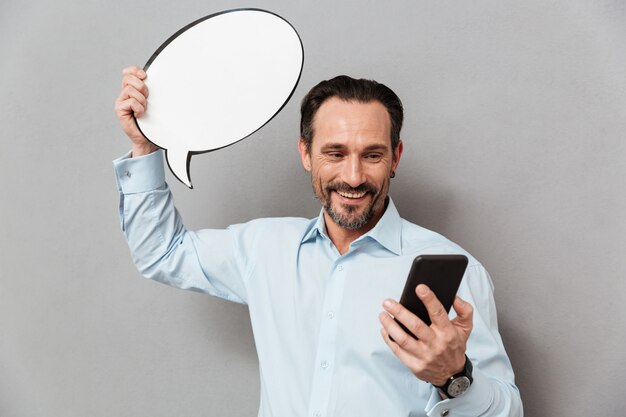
[0,0,626,417]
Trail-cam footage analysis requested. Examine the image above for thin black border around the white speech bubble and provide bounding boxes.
[133,7,304,189]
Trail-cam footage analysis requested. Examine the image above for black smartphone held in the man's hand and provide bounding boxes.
[396,255,467,337]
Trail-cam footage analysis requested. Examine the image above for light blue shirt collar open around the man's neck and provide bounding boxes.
[302,197,402,255]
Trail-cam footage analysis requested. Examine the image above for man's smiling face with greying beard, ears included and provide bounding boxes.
[298,97,402,233]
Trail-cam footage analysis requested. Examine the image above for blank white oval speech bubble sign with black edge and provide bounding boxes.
[136,9,304,188]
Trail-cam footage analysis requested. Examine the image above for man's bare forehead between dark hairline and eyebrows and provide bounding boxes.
[313,97,391,146]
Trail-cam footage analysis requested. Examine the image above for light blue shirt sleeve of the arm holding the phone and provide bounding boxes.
[425,263,523,417]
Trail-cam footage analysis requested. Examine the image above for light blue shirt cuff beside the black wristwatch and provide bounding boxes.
[424,367,493,417]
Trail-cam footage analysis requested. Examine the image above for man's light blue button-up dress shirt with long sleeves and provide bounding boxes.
[114,151,522,417]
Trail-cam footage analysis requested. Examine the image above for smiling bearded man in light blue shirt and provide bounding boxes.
[114,67,522,417]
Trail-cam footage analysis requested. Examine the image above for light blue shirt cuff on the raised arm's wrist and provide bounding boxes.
[113,150,165,194]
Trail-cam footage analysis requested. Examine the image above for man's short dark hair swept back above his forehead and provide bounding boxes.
[300,75,404,151]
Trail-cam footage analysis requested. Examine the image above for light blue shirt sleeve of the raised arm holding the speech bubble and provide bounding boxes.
[113,151,247,303]
